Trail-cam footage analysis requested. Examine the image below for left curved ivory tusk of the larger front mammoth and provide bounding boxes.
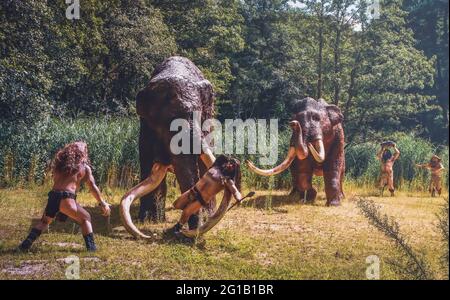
[120,163,170,239]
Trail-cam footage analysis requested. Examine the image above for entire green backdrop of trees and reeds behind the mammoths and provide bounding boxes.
[0,0,448,189]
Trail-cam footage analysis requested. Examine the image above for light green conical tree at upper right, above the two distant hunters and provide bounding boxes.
[346,0,433,142]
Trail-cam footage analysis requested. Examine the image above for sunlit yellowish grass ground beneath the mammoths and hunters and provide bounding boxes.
[0,185,445,279]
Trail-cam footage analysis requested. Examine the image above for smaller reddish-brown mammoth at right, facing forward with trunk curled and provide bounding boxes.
[247,98,345,206]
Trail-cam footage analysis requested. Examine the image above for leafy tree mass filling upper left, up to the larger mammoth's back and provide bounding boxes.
[0,0,177,121]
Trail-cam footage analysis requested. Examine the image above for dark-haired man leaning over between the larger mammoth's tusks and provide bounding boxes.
[169,155,242,236]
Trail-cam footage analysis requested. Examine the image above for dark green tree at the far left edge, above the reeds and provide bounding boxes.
[0,0,53,130]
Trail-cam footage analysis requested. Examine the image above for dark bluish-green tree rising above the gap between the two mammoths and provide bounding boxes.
[225,0,292,118]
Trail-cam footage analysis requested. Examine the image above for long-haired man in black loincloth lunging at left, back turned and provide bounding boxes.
[19,142,111,251]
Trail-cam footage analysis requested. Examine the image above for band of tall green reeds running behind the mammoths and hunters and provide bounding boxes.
[0,117,448,191]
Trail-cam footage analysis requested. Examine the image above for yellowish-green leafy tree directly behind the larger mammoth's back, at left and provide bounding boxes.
[53,0,177,116]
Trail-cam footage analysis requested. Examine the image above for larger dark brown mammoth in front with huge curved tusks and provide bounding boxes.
[120,56,241,238]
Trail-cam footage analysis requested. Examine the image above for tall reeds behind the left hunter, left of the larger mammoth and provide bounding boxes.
[0,118,139,186]
